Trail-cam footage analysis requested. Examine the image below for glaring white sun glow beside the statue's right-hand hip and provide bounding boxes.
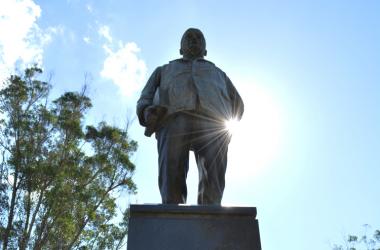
[225,82,282,179]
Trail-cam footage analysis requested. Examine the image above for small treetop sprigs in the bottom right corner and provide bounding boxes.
[333,225,380,250]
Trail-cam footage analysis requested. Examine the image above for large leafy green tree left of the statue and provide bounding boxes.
[0,67,137,249]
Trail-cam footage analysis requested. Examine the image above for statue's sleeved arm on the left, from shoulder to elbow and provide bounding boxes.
[136,67,161,126]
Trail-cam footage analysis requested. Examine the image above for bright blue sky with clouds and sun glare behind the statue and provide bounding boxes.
[0,0,380,250]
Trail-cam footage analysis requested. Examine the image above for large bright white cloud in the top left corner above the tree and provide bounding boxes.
[0,0,53,84]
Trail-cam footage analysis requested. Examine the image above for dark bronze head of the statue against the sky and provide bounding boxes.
[179,28,207,59]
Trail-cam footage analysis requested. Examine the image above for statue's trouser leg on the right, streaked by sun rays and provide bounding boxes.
[194,119,230,205]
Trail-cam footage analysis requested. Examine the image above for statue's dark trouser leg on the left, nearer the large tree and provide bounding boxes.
[156,115,190,204]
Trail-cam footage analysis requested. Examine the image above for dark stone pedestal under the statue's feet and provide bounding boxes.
[127,205,261,250]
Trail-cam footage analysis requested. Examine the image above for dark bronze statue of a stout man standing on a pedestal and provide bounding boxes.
[137,28,244,205]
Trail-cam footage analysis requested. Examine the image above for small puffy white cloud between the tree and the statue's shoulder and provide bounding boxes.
[100,42,147,96]
